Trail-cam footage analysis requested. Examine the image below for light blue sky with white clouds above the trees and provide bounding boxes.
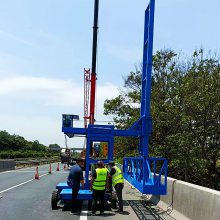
[0,0,220,147]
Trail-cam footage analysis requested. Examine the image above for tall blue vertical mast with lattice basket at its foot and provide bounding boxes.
[123,0,167,195]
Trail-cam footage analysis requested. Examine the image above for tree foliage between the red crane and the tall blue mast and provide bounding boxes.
[104,68,141,158]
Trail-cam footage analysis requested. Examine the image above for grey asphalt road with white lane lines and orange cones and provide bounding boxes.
[0,164,175,220]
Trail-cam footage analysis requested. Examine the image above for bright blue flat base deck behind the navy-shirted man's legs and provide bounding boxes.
[60,189,92,200]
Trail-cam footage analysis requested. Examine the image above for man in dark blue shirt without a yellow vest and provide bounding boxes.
[67,158,84,214]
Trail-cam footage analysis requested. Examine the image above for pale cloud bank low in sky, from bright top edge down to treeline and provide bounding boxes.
[0,75,118,147]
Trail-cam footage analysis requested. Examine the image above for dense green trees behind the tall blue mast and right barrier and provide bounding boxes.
[104,49,220,190]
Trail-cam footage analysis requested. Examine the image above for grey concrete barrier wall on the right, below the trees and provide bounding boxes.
[152,178,220,220]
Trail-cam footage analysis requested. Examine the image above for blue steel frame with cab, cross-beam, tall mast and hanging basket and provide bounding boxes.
[62,0,167,196]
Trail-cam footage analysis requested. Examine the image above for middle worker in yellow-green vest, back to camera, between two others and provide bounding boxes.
[90,161,108,215]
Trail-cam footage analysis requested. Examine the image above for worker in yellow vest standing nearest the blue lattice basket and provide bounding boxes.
[108,161,124,213]
